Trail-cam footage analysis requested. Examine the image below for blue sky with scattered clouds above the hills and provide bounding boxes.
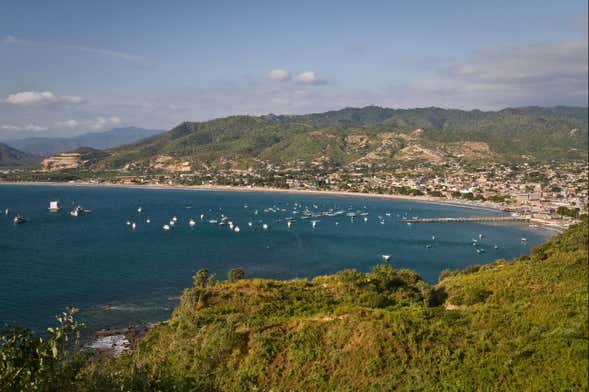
[0,0,588,139]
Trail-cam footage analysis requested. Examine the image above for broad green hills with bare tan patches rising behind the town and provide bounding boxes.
[89,106,588,169]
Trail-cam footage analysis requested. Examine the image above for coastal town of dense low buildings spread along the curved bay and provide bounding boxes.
[0,161,589,229]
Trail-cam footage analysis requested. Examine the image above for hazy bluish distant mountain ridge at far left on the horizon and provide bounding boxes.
[6,127,163,156]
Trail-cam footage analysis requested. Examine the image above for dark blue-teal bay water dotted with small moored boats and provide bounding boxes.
[0,185,550,329]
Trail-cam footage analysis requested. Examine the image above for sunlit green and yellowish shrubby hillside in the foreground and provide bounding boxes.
[0,216,589,391]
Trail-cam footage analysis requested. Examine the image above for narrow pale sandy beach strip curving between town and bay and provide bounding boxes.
[0,181,506,213]
